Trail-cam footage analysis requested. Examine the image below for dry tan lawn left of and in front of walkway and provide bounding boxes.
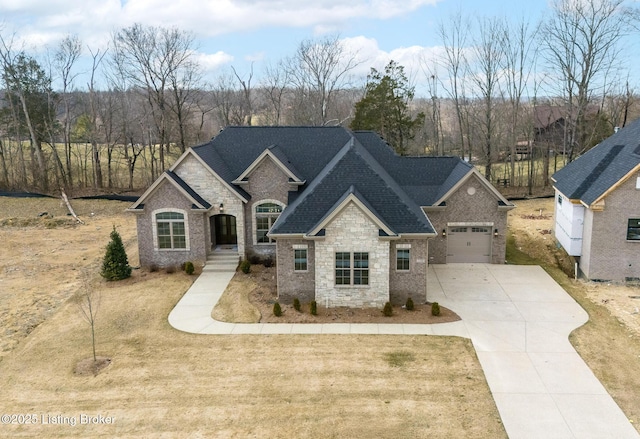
[0,198,506,438]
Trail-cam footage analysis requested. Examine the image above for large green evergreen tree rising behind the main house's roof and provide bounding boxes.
[351,60,425,154]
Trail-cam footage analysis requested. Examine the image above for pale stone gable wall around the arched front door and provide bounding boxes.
[175,155,246,256]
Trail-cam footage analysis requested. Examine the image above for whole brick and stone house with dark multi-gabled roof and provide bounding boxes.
[129,127,513,307]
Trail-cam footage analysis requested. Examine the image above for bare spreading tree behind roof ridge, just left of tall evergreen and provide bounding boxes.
[287,35,362,125]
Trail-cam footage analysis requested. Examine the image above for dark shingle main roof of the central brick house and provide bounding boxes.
[193,126,484,234]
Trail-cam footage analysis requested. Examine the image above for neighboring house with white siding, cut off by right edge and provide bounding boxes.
[552,119,640,282]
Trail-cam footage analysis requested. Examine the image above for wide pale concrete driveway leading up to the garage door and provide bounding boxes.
[428,264,640,439]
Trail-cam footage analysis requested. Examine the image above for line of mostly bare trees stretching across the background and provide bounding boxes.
[0,0,640,192]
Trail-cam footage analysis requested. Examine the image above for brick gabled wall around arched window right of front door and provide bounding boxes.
[243,157,296,256]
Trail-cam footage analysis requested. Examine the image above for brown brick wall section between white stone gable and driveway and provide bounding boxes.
[389,239,429,305]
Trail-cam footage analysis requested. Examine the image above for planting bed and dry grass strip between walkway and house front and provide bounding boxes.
[212,265,460,324]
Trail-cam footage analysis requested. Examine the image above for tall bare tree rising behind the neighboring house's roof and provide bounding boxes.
[540,0,640,160]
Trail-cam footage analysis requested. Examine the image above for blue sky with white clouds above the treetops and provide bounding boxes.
[0,0,640,94]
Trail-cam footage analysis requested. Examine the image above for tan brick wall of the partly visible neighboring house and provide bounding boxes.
[579,175,640,282]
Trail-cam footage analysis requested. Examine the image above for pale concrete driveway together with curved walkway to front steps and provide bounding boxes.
[169,264,640,439]
